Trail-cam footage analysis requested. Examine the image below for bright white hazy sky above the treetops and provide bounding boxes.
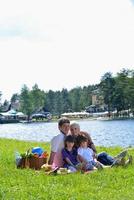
[0,0,134,100]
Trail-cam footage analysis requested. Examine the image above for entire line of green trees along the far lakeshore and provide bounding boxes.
[0,69,134,116]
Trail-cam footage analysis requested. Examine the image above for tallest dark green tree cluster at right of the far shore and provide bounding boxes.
[100,69,134,114]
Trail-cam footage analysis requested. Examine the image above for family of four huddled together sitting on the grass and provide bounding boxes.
[48,117,132,172]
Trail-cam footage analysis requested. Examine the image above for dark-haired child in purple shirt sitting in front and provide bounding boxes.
[62,135,80,172]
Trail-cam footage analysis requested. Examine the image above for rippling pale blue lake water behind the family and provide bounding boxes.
[0,120,134,146]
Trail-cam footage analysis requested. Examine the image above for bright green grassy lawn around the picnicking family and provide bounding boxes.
[0,139,134,200]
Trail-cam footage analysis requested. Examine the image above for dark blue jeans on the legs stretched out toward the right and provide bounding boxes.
[97,152,114,165]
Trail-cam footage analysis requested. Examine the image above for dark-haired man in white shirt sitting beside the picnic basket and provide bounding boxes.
[48,117,70,168]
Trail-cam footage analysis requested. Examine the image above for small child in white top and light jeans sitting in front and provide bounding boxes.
[78,135,103,170]
